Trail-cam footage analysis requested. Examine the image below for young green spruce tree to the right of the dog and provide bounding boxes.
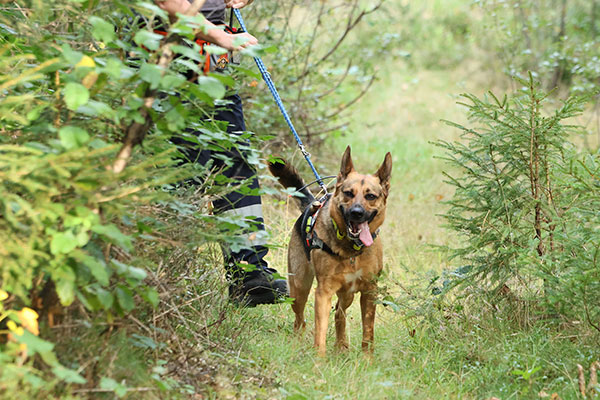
[438,75,600,330]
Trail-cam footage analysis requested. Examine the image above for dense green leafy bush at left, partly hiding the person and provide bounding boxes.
[0,0,258,397]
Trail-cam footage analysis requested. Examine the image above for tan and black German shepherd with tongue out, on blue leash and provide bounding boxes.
[269,146,392,355]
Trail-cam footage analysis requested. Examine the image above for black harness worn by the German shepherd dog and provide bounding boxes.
[294,194,379,260]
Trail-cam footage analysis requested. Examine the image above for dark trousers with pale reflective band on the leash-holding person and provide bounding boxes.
[173,94,268,279]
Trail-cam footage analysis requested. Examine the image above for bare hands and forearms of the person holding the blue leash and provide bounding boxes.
[155,0,258,50]
